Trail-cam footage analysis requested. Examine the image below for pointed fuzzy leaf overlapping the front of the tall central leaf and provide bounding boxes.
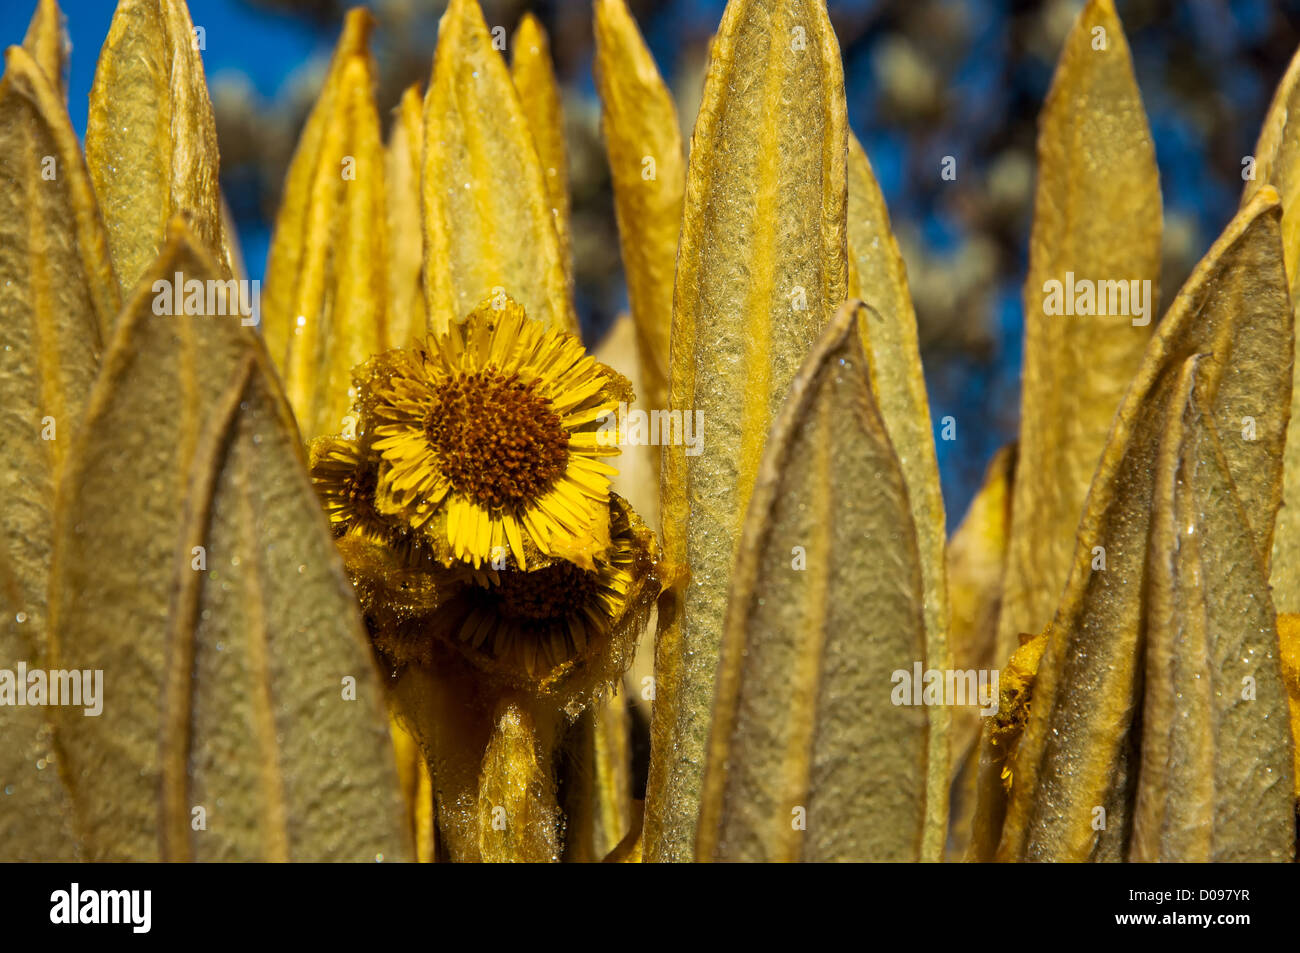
[697,303,948,861]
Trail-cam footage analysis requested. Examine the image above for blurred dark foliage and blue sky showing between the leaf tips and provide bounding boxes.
[10,0,1300,517]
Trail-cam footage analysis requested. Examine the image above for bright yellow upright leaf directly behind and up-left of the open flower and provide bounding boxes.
[263,10,387,439]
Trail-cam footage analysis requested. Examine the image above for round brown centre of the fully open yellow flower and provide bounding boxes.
[424,368,568,508]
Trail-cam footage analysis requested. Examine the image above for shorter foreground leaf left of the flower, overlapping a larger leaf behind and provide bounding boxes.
[158,358,412,861]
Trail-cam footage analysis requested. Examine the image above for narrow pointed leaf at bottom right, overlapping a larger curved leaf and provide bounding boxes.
[1130,358,1296,862]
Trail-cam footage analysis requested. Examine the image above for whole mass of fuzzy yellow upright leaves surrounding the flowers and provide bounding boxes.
[0,0,1300,861]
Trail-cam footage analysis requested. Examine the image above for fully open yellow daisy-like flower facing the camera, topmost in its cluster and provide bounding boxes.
[358,296,632,571]
